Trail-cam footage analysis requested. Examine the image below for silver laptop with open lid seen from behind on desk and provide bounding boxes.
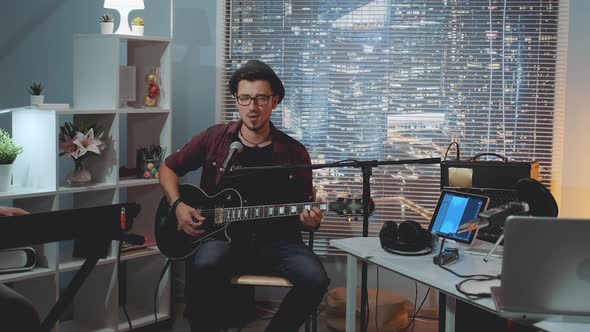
[491,216,590,322]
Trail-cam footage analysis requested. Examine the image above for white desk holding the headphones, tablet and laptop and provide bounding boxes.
[330,237,590,332]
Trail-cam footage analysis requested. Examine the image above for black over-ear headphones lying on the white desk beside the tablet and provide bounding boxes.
[379,220,432,256]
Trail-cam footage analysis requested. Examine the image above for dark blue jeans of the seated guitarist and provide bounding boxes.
[185,240,330,332]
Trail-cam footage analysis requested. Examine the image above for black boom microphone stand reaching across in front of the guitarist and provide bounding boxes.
[230,158,440,332]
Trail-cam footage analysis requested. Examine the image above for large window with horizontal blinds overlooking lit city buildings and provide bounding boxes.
[218,0,568,255]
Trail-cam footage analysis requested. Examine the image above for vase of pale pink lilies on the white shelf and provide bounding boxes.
[59,122,107,186]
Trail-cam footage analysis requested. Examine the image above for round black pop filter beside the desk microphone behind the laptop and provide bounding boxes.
[516,178,558,217]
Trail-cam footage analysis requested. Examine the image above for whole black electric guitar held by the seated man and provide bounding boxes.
[155,184,375,259]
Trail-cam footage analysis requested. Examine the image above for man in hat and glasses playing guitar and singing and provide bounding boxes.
[159,60,329,332]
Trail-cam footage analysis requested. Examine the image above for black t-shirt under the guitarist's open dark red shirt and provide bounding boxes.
[218,144,301,243]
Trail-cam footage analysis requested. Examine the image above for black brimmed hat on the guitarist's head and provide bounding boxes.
[228,60,285,103]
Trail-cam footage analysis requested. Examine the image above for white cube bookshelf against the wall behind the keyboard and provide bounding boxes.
[0,35,173,332]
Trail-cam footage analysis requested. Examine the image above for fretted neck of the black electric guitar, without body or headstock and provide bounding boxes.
[222,202,329,222]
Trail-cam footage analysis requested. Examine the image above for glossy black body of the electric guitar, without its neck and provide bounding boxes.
[155,184,242,260]
